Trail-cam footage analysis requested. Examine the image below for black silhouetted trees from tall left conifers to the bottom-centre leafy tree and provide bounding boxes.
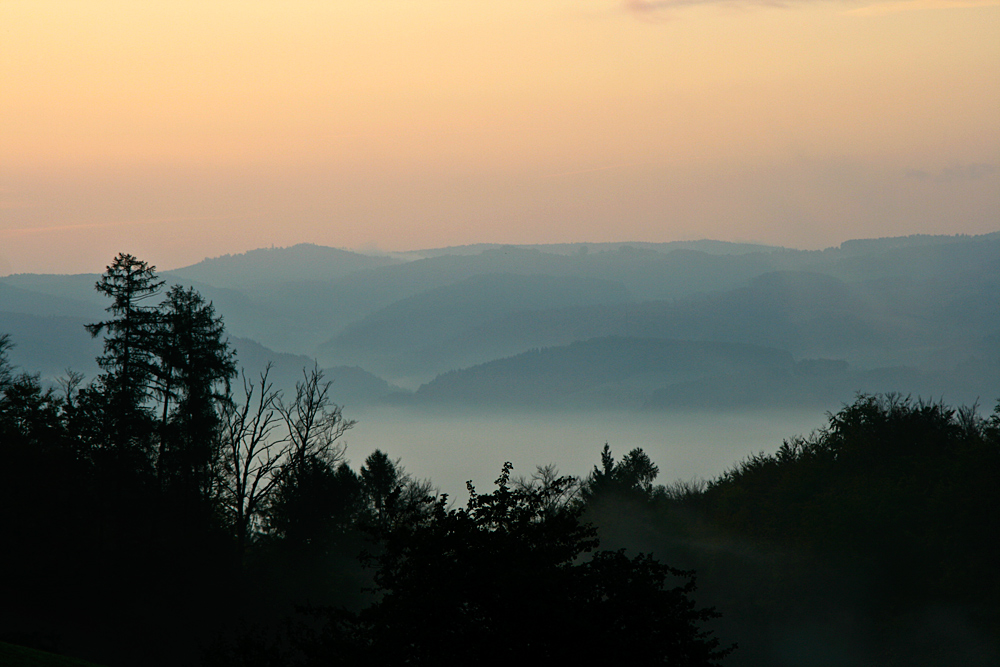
[0,254,728,666]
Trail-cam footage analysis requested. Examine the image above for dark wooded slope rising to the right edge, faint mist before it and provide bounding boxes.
[587,395,1000,665]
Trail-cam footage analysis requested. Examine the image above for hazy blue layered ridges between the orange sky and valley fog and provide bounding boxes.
[0,233,1000,409]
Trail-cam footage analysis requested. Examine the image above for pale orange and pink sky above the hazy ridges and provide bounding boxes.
[0,0,1000,275]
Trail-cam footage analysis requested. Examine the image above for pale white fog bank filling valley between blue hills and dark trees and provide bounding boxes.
[345,406,825,503]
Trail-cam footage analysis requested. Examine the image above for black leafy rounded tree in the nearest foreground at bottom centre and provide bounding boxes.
[348,463,729,666]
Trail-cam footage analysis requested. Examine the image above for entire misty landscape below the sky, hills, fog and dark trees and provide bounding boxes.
[0,233,1000,667]
